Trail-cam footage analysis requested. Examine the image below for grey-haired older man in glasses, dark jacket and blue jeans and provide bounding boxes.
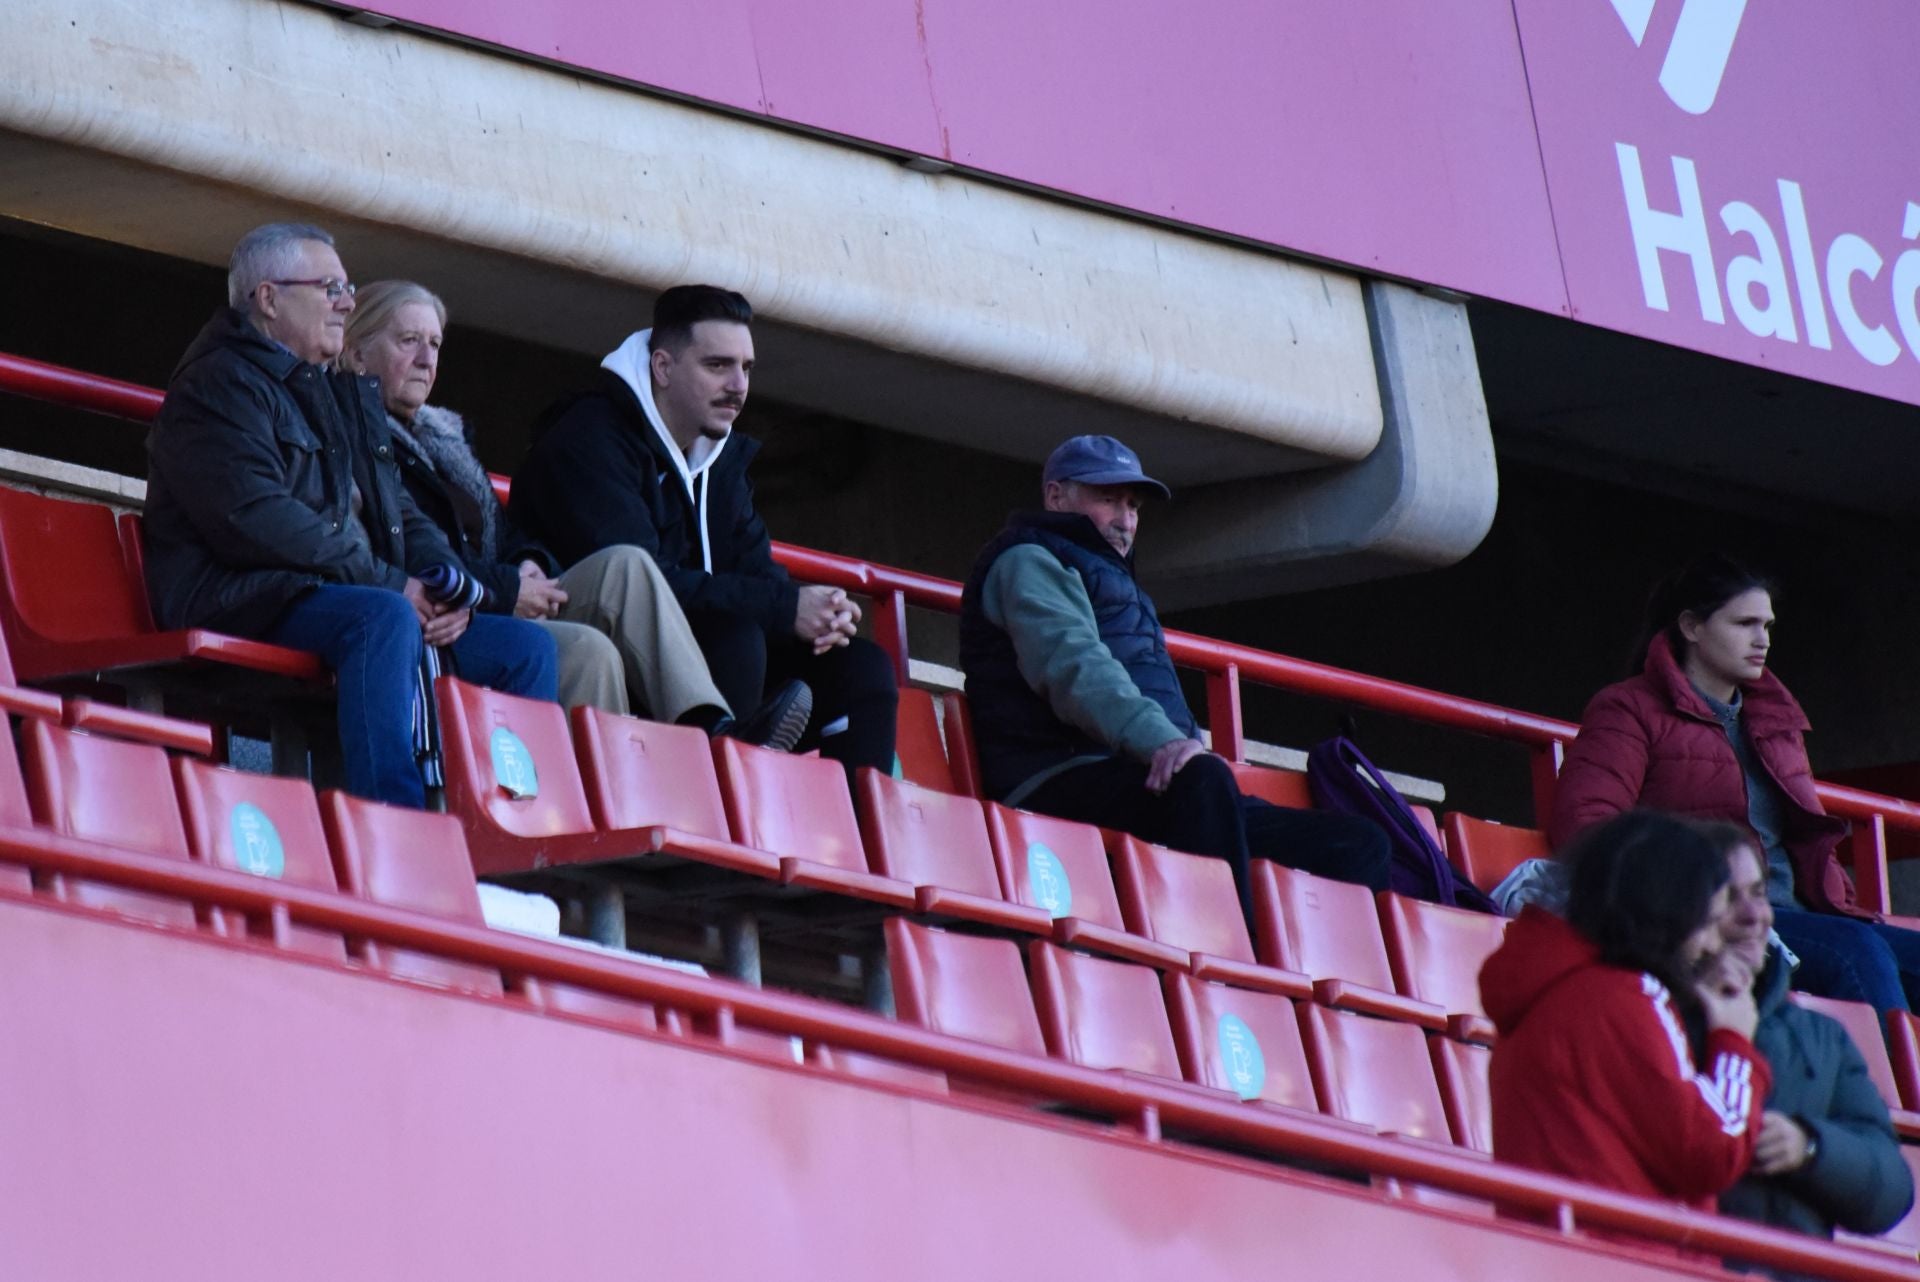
[146,223,555,806]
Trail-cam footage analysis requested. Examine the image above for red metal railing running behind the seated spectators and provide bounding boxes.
[0,353,1920,912]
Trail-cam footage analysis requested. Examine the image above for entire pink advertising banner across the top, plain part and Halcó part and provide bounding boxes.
[360,0,1920,403]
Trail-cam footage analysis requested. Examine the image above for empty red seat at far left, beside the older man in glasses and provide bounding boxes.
[0,489,326,681]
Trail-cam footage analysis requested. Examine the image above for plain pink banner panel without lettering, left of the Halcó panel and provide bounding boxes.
[369,0,1567,313]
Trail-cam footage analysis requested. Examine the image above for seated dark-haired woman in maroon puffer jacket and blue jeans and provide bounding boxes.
[1549,555,1920,1011]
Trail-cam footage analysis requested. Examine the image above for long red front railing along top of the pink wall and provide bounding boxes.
[0,829,1916,1282]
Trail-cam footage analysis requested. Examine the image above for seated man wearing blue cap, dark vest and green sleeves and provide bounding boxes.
[960,436,1388,906]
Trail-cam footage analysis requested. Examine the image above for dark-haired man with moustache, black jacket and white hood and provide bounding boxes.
[511,284,899,773]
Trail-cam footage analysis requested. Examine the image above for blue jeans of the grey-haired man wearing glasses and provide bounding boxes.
[263,585,559,810]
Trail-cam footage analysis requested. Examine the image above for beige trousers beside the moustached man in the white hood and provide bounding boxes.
[538,545,732,722]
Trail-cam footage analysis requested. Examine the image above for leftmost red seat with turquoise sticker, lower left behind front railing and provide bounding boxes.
[173,758,346,962]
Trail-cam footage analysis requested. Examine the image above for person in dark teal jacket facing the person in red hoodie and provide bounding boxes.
[1709,823,1914,1238]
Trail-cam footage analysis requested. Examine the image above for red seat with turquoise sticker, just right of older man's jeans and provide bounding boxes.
[434,677,780,879]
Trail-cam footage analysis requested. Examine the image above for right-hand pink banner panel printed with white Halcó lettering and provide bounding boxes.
[1515,0,1920,403]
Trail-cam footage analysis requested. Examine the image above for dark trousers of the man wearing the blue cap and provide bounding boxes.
[1020,752,1392,921]
